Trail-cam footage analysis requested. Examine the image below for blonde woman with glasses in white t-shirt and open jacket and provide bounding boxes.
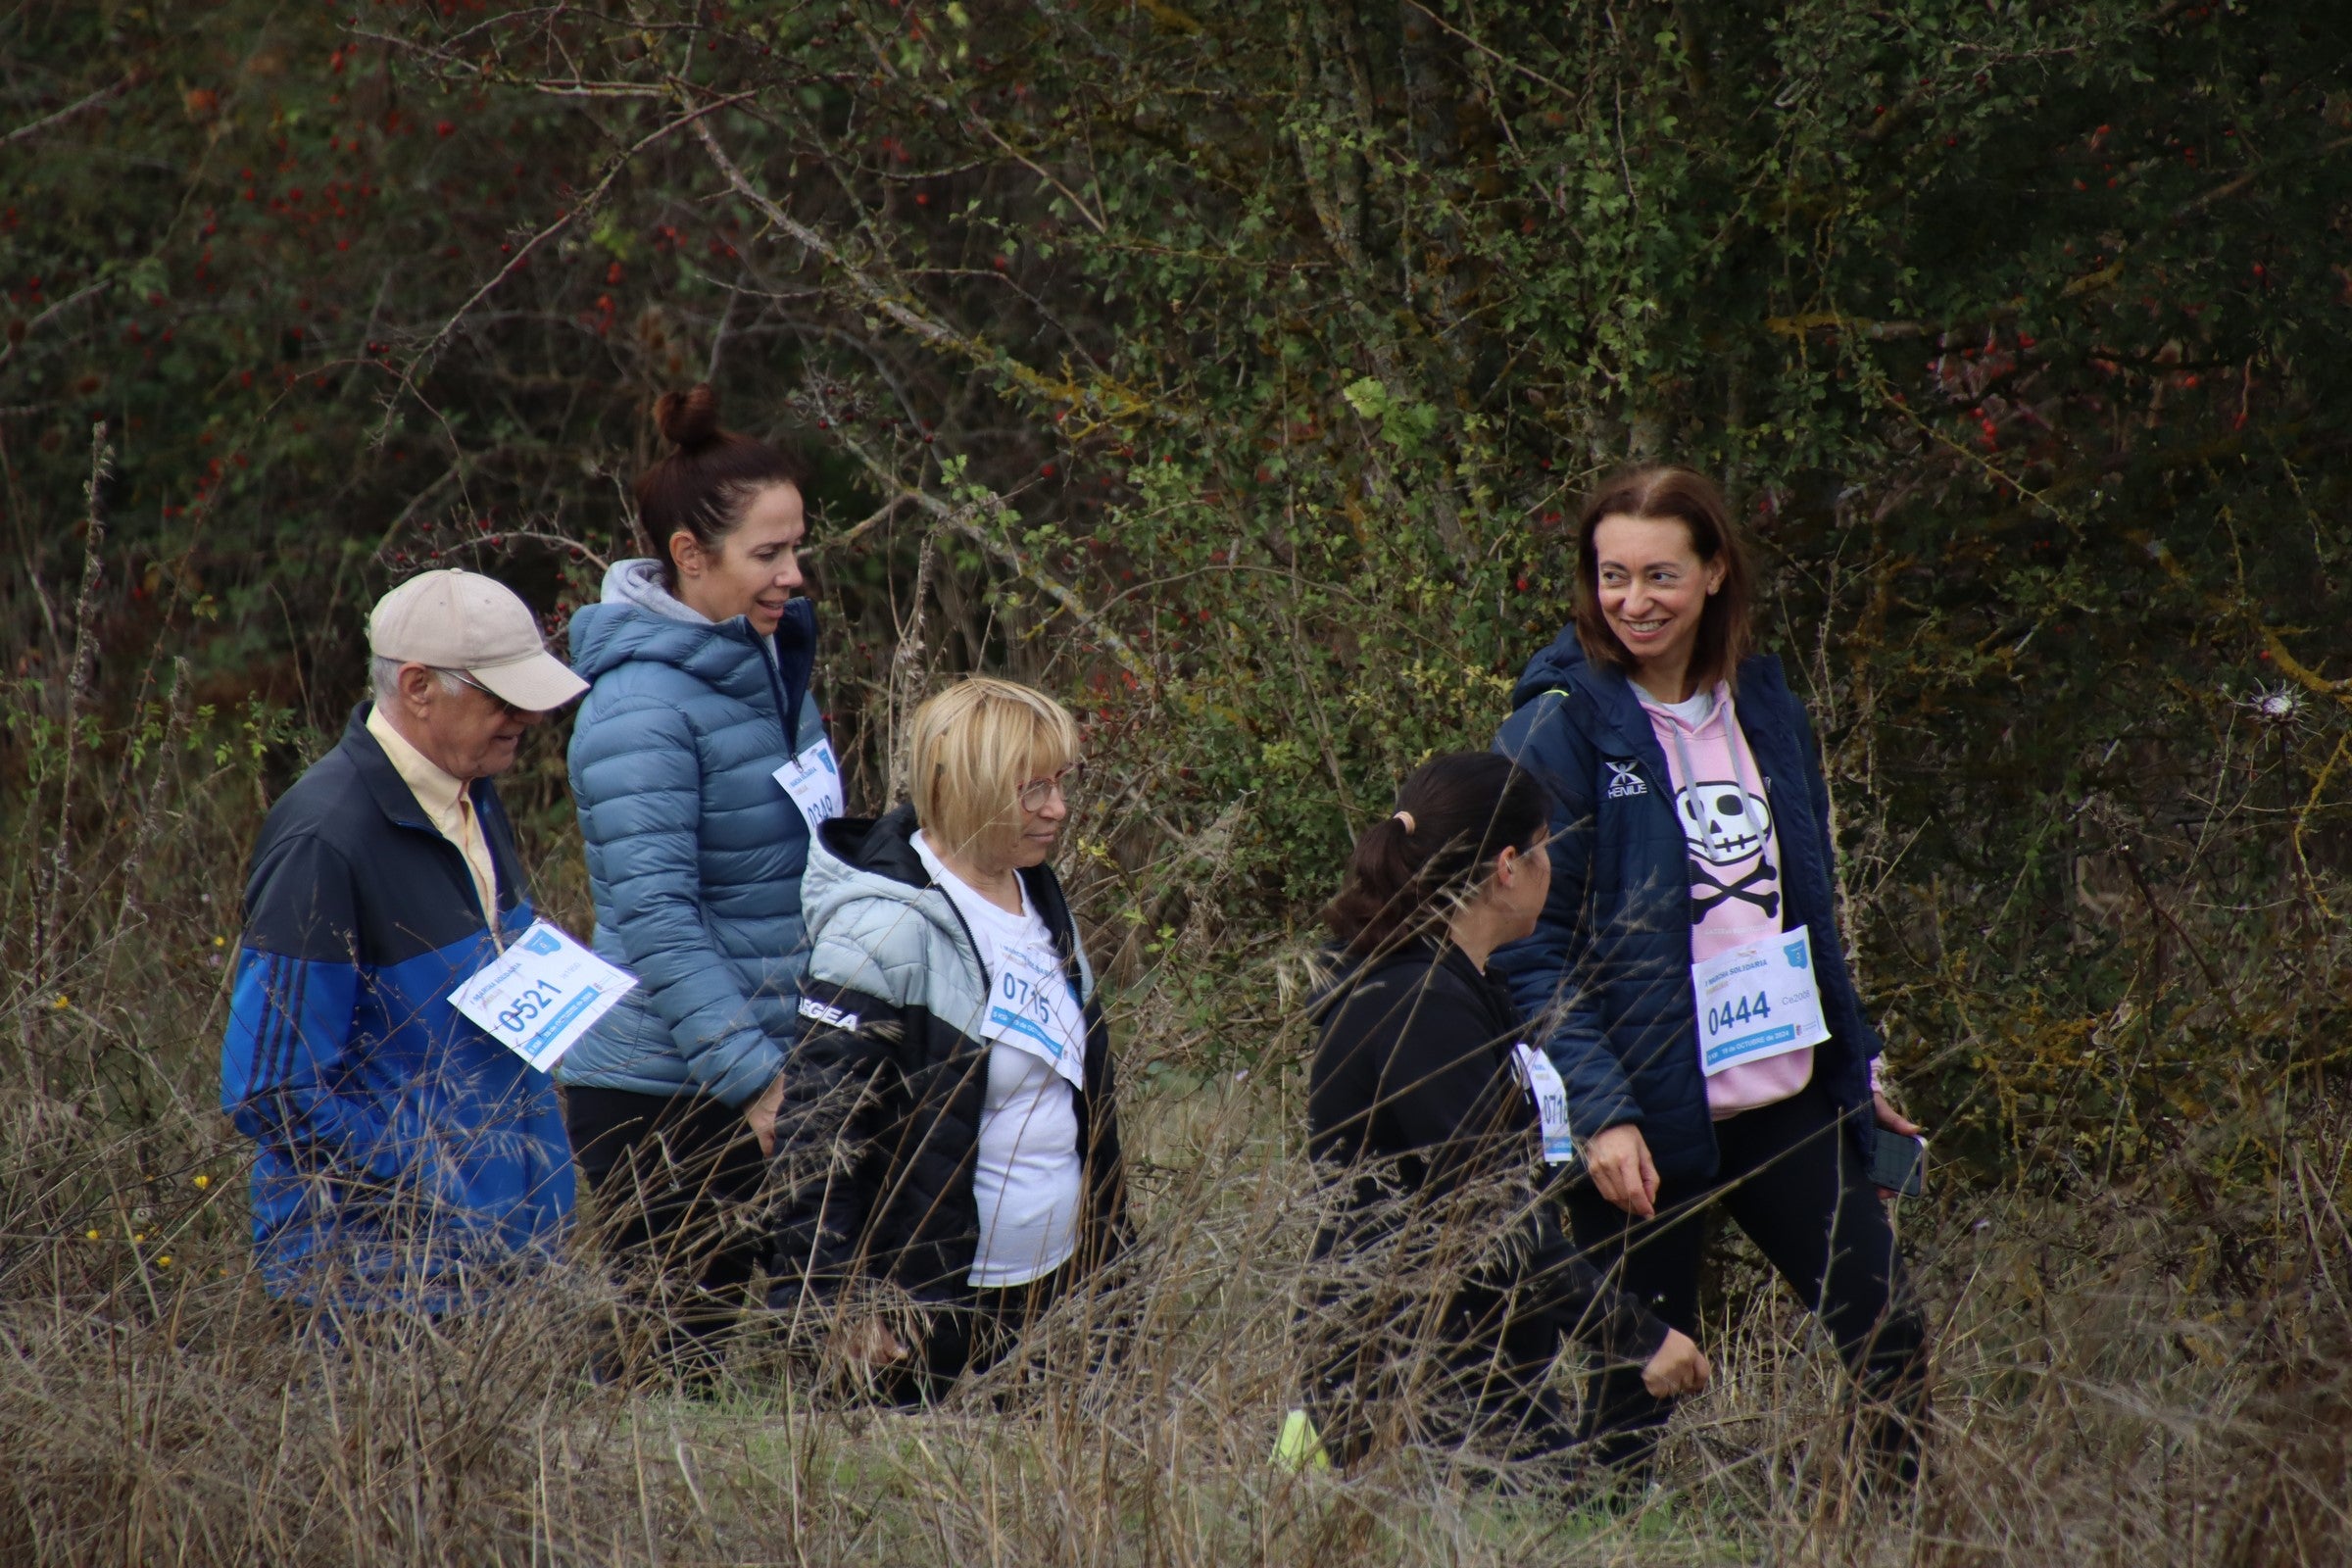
[769,677,1124,1401]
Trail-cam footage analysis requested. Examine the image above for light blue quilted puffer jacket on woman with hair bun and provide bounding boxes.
[555,560,825,1104]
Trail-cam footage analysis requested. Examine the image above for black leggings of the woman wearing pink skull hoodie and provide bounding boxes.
[1566,1084,1927,1479]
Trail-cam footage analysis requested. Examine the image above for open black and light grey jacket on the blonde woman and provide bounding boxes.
[769,807,1124,1312]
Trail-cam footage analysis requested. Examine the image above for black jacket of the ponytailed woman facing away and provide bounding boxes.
[1307,941,1665,1361]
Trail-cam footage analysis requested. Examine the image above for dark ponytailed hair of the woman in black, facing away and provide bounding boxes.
[1324,753,1552,956]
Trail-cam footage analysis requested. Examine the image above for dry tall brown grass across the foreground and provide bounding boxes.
[0,906,2352,1566]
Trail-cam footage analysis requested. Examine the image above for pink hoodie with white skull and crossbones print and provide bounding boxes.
[1635,682,1813,1121]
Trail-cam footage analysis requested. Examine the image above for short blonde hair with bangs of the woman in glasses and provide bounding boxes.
[907,674,1077,856]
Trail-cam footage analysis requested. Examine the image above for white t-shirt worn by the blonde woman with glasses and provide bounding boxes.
[915,832,1087,1289]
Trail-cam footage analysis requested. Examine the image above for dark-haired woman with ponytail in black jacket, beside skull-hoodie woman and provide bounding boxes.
[1307,753,1707,1462]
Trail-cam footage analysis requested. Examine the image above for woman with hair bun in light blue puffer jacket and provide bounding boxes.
[555,385,842,1375]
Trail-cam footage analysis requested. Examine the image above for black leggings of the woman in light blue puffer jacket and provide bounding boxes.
[564,1089,766,1375]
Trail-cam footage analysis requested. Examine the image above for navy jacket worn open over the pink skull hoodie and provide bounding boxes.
[1492,625,1880,1180]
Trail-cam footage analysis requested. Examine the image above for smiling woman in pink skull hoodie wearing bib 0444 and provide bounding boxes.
[1494,467,1927,1476]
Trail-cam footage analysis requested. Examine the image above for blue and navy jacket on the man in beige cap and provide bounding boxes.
[221,706,571,1309]
